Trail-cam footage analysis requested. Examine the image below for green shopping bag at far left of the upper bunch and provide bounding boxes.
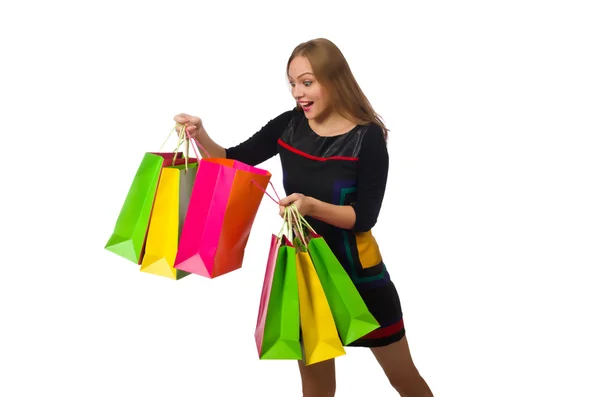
[104,152,187,264]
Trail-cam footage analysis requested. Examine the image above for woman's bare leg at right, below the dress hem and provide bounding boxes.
[371,336,433,397]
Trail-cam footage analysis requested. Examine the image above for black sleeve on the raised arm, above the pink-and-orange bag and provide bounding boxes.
[225,110,296,166]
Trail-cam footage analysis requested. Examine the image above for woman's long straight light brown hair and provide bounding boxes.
[287,38,389,140]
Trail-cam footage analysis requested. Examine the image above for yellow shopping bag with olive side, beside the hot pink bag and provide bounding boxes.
[140,159,198,280]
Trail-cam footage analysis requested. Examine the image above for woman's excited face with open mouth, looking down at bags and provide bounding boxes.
[288,56,331,120]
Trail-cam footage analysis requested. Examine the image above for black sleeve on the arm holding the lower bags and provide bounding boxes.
[352,125,389,232]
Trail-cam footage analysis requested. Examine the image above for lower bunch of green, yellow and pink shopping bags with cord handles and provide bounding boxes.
[254,205,379,365]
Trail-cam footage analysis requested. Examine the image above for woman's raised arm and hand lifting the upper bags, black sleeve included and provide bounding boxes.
[174,110,297,166]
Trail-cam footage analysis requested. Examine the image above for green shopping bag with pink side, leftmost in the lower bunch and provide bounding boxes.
[254,235,302,360]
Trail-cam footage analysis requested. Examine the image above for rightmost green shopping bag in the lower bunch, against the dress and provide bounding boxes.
[292,206,380,346]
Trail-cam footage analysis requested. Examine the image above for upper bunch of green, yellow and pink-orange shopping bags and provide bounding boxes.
[105,128,271,280]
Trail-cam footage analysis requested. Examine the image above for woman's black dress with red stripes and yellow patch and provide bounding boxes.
[226,109,404,347]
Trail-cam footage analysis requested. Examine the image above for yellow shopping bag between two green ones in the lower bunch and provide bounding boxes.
[296,247,346,365]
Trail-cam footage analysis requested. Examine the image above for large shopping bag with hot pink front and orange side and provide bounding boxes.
[175,158,271,278]
